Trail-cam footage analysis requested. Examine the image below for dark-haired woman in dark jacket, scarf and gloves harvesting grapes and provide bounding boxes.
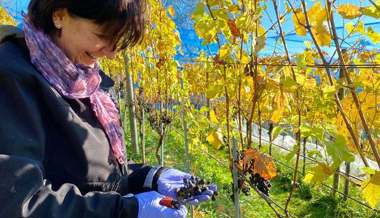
[0,0,216,218]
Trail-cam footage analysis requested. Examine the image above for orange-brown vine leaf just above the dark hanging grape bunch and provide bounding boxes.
[240,148,277,180]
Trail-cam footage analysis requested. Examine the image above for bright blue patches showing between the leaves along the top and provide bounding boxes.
[0,0,380,61]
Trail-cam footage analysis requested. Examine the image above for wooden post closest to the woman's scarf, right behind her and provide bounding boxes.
[124,55,139,155]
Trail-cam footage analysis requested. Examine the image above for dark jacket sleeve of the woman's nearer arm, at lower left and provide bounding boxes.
[0,71,138,218]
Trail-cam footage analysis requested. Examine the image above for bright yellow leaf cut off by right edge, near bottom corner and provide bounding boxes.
[362,171,380,208]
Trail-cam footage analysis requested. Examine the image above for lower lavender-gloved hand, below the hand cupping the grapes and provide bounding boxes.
[134,191,187,218]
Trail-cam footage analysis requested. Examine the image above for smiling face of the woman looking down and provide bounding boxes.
[53,9,115,67]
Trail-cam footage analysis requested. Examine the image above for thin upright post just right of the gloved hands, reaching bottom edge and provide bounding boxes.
[232,138,241,218]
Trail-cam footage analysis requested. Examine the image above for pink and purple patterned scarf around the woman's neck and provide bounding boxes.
[24,17,125,164]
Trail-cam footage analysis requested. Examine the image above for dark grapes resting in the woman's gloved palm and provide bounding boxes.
[177,176,218,202]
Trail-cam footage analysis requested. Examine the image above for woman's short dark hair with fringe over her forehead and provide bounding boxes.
[28,0,145,50]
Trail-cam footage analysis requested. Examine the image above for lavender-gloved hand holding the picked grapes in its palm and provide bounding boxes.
[157,169,217,205]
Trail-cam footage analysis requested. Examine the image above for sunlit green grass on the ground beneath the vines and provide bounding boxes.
[120,110,380,218]
